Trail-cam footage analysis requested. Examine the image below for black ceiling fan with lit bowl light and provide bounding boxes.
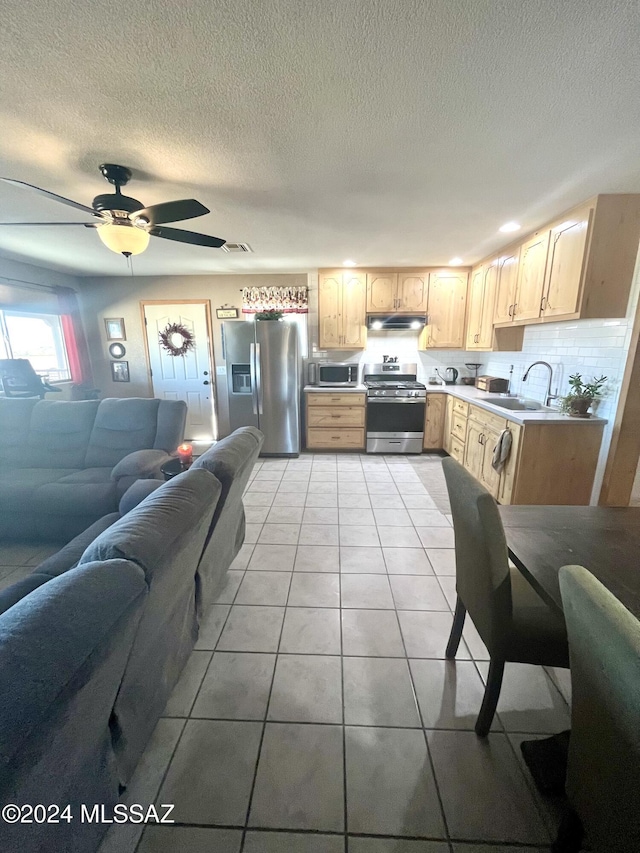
[0,163,226,258]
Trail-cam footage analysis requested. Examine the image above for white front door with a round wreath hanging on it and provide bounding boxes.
[144,302,218,441]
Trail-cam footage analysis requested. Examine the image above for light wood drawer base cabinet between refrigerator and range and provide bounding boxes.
[306,391,366,450]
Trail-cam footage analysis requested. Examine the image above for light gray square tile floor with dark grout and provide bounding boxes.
[0,454,569,853]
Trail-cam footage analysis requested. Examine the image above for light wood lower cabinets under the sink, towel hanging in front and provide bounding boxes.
[442,396,604,506]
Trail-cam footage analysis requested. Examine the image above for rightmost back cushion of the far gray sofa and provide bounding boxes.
[83,397,160,468]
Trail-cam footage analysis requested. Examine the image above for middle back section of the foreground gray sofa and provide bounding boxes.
[79,470,220,783]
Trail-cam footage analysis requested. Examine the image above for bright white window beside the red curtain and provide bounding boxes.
[0,310,71,382]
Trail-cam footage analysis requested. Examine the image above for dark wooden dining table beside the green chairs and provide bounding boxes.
[500,506,640,619]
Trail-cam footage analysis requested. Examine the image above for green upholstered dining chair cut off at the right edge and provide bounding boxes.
[553,566,640,853]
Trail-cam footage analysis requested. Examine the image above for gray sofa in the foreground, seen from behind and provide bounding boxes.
[0,427,262,853]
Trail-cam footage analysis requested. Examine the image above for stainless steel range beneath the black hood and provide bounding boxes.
[363,361,427,453]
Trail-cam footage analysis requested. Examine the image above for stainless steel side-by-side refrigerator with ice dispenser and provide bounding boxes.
[222,320,300,456]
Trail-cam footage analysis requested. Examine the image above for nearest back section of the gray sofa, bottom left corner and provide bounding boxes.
[0,561,147,853]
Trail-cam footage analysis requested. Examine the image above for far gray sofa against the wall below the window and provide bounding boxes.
[0,397,187,542]
